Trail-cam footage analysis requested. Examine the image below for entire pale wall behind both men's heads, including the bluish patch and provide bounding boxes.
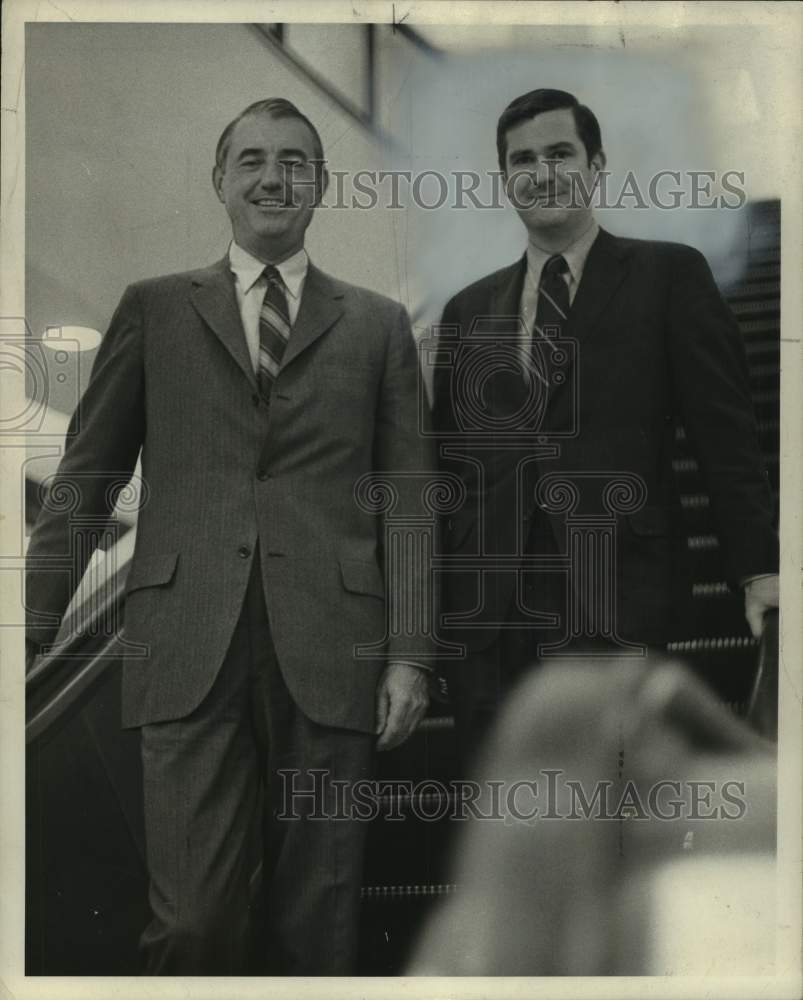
[26,24,799,411]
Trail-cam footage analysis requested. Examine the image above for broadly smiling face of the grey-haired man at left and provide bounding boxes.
[212,113,328,264]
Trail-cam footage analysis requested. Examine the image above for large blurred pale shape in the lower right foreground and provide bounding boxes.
[406,659,776,976]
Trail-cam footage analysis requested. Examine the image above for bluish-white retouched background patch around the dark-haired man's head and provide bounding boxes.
[384,26,790,332]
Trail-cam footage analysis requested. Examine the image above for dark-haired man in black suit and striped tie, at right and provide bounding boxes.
[434,90,778,755]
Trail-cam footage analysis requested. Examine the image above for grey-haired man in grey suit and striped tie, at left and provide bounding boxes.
[27,99,428,975]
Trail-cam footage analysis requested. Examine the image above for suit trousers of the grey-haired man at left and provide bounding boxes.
[140,552,374,975]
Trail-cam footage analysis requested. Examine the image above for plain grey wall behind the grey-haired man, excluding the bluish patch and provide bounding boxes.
[26,24,406,411]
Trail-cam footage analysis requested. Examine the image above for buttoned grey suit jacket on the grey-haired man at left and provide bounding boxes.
[27,259,428,732]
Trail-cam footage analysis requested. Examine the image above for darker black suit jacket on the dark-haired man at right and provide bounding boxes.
[434,231,778,648]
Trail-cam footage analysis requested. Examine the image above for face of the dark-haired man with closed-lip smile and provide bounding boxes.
[505,108,605,245]
